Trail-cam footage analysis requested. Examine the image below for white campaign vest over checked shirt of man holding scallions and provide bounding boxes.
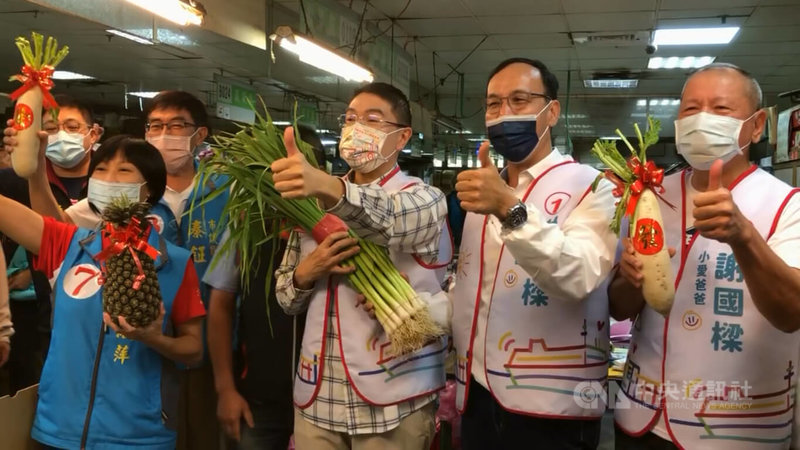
[294,168,453,409]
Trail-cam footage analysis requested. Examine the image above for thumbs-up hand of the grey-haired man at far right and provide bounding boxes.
[692,159,754,246]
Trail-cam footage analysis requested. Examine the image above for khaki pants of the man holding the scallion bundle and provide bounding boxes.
[294,402,436,450]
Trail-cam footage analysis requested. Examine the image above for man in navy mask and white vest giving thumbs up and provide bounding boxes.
[450,58,616,449]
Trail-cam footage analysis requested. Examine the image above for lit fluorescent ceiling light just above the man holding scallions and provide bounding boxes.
[269,26,374,82]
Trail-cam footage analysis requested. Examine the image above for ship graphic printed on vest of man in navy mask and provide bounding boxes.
[488,320,608,395]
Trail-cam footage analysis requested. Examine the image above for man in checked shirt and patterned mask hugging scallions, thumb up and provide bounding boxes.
[272,83,453,450]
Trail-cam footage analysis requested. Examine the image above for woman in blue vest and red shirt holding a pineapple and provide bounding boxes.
[0,130,205,450]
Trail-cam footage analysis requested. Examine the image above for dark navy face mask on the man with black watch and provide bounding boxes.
[486,103,550,163]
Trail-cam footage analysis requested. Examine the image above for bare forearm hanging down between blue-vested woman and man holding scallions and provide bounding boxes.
[208,289,236,393]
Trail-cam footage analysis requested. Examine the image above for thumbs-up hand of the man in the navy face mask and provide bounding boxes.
[456,141,519,221]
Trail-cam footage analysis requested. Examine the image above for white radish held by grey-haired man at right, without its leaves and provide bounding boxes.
[630,189,675,316]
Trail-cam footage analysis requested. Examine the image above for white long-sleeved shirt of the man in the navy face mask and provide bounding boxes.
[472,148,617,388]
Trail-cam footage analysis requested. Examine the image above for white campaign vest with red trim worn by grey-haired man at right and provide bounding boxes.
[615,166,800,450]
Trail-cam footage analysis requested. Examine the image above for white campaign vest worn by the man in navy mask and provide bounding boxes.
[452,161,609,418]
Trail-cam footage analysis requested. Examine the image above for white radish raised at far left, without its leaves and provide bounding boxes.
[11,86,42,178]
